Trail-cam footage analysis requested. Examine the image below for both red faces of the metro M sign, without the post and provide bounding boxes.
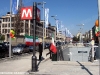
[21,7,40,21]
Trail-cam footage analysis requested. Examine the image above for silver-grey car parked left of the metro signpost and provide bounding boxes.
[12,44,30,54]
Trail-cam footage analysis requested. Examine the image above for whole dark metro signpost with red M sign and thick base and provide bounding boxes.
[21,2,40,72]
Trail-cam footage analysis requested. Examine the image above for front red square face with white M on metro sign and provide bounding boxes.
[21,7,33,20]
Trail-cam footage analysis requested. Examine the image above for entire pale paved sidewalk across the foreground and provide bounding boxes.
[0,50,99,75]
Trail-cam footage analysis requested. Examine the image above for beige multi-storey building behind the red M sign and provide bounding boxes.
[0,13,43,38]
